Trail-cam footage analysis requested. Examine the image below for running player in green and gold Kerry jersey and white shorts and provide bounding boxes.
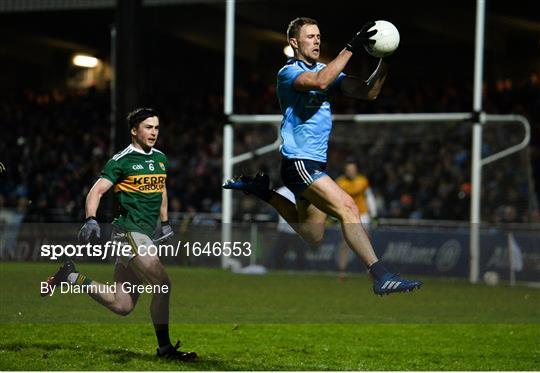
[42,108,197,361]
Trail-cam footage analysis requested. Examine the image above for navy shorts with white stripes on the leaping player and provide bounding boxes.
[281,158,327,198]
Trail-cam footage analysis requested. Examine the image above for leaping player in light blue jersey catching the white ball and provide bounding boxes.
[223,17,422,295]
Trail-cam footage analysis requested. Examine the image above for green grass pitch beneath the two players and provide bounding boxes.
[0,263,540,370]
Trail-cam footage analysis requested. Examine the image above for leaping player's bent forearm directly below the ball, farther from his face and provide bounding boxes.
[341,59,388,100]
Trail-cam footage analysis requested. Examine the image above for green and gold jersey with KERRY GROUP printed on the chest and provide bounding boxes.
[101,145,169,237]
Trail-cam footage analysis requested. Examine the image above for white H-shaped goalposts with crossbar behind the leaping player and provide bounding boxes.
[221,0,530,283]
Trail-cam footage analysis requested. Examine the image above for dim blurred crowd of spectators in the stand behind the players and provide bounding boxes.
[0,74,540,222]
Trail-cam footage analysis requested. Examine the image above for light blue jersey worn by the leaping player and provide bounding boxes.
[277,58,345,162]
